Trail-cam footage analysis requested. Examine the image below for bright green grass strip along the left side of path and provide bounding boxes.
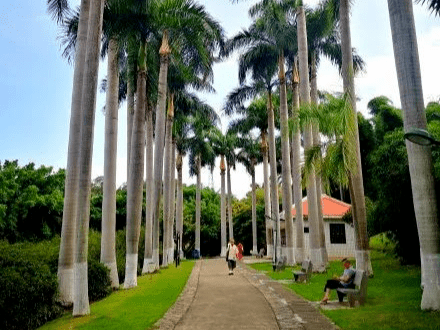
[40,261,194,330]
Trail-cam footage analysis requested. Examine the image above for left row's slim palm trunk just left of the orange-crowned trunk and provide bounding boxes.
[142,103,155,273]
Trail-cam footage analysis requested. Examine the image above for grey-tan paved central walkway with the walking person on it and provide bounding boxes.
[175,259,279,330]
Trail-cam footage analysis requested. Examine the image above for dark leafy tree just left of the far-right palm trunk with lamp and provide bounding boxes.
[368,128,420,264]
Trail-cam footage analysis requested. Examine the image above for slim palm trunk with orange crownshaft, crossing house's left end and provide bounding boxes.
[278,51,295,265]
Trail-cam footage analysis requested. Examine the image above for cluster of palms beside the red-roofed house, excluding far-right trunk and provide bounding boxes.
[224,0,372,273]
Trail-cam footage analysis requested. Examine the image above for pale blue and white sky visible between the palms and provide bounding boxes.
[0,0,440,198]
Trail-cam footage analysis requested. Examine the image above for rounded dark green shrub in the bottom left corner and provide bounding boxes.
[0,242,62,329]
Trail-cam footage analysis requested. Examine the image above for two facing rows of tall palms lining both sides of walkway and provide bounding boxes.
[48,0,439,315]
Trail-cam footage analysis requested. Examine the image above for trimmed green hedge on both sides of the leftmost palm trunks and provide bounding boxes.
[0,230,112,329]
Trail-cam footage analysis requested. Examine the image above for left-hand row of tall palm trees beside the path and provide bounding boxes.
[49,0,224,315]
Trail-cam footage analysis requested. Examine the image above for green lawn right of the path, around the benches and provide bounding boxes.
[252,251,440,330]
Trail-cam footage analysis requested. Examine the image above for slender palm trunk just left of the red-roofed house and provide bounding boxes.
[267,91,281,262]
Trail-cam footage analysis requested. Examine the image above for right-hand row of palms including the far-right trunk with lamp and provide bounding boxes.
[225,0,440,310]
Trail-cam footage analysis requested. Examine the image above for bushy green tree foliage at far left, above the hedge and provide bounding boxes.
[0,160,65,242]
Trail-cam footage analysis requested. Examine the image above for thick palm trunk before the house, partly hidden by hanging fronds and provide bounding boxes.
[297,6,324,271]
